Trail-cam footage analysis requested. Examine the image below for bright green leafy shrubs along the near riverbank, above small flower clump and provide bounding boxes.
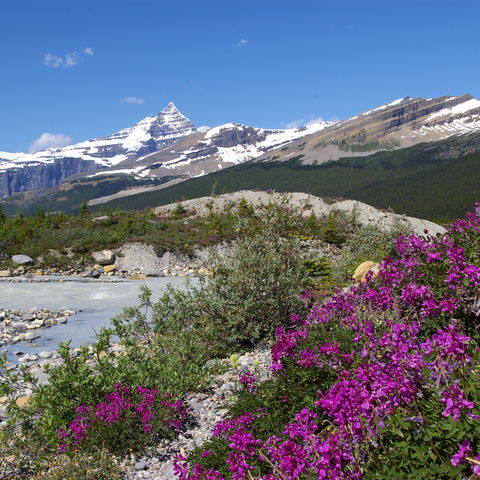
[0,287,221,449]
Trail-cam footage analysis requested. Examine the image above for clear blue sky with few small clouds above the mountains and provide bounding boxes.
[0,0,480,152]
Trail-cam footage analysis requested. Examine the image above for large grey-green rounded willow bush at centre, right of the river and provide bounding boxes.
[176,209,316,354]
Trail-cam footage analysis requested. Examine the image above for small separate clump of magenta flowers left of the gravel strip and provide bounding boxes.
[58,384,187,453]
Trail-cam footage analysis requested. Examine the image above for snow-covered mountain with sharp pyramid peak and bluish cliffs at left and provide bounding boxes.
[0,102,196,197]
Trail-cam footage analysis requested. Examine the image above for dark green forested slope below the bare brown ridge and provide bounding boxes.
[94,134,480,221]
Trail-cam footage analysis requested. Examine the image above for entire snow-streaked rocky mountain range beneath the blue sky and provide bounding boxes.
[0,95,480,204]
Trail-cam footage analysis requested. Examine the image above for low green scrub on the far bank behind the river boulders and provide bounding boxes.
[0,210,238,268]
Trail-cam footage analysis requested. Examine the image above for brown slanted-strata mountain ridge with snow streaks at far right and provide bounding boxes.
[258,95,480,164]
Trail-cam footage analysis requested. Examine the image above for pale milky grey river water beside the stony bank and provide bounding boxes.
[0,277,191,358]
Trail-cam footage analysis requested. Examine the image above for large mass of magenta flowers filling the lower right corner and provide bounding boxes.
[175,204,480,480]
